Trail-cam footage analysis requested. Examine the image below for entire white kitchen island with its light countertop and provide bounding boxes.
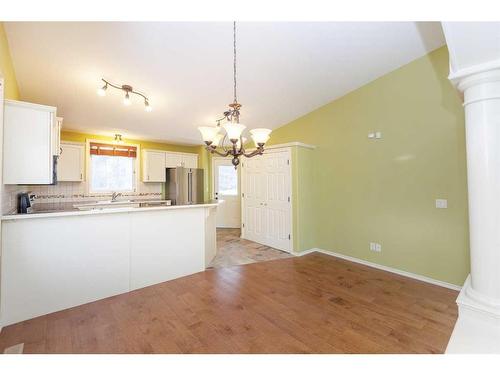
[0,203,217,326]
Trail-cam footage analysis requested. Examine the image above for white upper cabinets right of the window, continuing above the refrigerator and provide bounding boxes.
[142,150,198,182]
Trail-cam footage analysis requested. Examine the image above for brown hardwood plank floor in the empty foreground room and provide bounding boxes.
[0,253,457,353]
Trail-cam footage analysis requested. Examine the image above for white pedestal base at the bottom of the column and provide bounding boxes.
[446,275,500,354]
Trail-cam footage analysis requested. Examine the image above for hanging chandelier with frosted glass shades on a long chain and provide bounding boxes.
[198,22,271,169]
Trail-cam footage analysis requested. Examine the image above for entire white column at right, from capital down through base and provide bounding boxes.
[447,69,500,353]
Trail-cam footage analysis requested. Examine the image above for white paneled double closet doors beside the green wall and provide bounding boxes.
[242,149,292,252]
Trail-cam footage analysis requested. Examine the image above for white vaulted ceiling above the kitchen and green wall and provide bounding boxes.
[5,22,444,144]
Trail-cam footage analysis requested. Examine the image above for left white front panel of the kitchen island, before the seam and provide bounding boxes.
[1,213,130,326]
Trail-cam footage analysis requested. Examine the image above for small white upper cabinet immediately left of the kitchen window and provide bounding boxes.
[57,143,85,182]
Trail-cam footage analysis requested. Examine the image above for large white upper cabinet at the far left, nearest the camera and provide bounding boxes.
[3,100,62,185]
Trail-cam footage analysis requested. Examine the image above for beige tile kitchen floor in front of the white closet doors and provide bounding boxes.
[210,228,292,268]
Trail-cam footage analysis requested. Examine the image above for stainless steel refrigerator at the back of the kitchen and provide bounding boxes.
[165,167,204,205]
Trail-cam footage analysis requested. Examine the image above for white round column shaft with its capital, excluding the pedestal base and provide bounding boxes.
[458,69,500,308]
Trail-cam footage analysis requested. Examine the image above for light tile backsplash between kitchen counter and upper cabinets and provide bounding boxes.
[2,182,163,215]
